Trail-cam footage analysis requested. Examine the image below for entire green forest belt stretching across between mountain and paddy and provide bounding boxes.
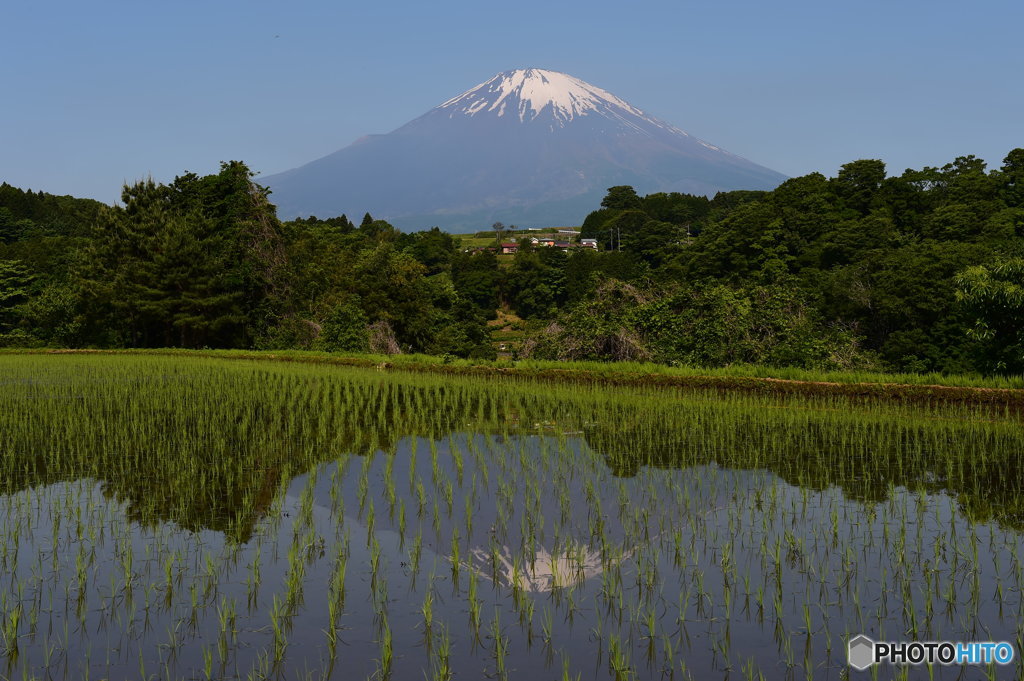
[0,148,1024,375]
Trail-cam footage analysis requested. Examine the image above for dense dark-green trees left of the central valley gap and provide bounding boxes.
[0,162,494,356]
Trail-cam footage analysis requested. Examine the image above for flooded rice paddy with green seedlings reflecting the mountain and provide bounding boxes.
[0,355,1024,681]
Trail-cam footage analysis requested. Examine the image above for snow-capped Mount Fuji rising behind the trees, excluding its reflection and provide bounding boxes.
[262,69,785,229]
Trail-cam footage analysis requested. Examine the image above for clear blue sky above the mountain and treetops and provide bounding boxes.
[0,0,1024,202]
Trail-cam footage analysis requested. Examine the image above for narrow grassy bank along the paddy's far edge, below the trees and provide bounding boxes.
[3,349,1024,407]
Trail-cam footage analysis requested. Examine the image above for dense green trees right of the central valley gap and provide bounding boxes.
[542,150,1024,372]
